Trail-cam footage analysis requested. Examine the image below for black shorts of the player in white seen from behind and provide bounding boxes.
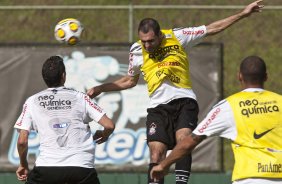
[26,167,100,184]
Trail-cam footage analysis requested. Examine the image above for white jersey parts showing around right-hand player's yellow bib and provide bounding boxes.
[193,88,282,184]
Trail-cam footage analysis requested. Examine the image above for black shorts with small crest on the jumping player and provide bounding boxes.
[146,98,199,150]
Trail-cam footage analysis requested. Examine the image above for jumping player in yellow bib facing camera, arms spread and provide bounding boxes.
[88,0,263,184]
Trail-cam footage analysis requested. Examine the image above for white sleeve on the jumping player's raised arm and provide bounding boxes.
[173,25,207,49]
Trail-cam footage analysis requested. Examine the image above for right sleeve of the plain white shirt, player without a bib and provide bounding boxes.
[83,95,106,122]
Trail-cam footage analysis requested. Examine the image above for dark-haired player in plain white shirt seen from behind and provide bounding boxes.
[14,56,115,184]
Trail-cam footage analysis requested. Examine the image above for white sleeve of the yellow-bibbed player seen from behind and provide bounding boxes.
[193,100,237,140]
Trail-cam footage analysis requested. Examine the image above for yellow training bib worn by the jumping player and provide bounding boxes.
[141,30,191,95]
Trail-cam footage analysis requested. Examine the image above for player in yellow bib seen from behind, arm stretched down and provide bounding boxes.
[151,56,282,184]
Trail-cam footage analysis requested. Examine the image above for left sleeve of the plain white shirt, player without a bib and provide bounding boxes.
[14,98,32,131]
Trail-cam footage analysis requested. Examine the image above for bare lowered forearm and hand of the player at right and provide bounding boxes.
[150,133,206,181]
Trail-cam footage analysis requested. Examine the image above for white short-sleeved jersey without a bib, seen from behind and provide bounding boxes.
[14,87,105,168]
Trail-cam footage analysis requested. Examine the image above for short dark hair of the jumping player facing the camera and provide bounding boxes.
[138,18,161,35]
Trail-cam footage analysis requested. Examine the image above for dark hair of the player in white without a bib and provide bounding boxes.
[42,56,66,87]
